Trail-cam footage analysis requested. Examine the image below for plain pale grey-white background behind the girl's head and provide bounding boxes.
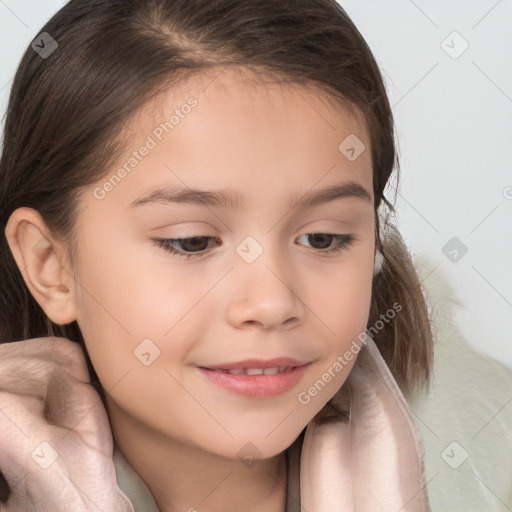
[0,0,512,368]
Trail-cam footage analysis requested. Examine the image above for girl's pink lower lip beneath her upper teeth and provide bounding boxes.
[198,363,309,397]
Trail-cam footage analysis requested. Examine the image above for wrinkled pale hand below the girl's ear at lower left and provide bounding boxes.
[0,337,134,512]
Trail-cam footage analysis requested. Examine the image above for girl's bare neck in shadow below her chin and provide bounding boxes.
[108,400,287,512]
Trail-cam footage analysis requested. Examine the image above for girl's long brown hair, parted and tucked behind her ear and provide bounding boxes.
[0,0,433,400]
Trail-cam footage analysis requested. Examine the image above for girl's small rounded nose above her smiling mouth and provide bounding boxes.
[226,248,305,330]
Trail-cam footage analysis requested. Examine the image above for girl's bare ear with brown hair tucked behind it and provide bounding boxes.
[5,207,77,325]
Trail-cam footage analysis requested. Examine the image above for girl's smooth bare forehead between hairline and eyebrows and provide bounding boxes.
[98,67,372,206]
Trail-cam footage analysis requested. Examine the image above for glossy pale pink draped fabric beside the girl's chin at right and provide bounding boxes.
[300,337,430,512]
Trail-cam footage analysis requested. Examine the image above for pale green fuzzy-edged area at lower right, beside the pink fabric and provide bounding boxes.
[405,254,512,512]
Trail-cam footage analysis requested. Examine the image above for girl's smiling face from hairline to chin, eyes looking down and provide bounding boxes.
[69,70,375,458]
